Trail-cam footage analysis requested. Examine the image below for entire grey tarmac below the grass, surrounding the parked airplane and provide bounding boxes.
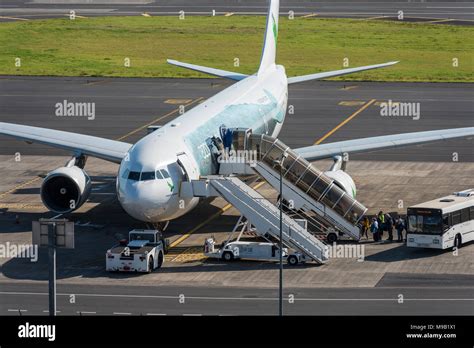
[0,77,474,315]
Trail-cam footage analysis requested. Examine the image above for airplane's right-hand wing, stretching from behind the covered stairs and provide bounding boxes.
[294,127,474,161]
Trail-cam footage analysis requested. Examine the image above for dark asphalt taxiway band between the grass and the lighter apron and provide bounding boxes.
[0,77,474,162]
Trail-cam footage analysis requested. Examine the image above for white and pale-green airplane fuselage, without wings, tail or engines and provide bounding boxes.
[117,65,288,222]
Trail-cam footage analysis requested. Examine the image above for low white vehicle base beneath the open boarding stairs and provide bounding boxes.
[204,238,306,266]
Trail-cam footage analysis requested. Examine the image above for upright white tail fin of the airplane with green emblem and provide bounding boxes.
[258,0,280,74]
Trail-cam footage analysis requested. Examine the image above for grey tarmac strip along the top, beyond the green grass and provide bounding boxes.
[0,0,474,25]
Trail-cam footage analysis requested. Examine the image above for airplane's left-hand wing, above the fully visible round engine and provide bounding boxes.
[0,122,132,163]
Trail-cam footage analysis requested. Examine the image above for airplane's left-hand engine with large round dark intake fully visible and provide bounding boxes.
[41,166,92,214]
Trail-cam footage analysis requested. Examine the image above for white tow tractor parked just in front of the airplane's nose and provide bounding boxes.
[106,229,167,273]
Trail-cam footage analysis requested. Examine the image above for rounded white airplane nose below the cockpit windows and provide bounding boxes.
[119,180,171,222]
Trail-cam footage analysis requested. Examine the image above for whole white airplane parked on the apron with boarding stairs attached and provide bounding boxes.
[0,0,474,223]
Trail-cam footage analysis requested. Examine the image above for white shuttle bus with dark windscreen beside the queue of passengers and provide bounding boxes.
[407,189,474,249]
